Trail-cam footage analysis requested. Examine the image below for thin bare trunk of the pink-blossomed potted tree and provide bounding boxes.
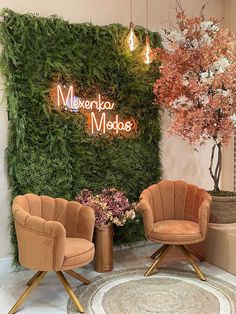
[209,143,222,192]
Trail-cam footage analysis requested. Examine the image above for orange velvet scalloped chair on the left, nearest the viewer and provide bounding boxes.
[9,194,95,314]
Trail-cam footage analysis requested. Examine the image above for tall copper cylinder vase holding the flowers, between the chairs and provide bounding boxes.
[95,225,113,273]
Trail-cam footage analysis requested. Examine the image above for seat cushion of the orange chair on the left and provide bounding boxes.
[62,238,94,270]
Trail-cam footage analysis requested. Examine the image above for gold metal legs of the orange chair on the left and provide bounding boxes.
[8,270,90,314]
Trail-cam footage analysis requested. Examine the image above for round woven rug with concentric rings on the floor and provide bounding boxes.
[67,268,236,314]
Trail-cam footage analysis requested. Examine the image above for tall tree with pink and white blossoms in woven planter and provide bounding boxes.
[154,5,236,223]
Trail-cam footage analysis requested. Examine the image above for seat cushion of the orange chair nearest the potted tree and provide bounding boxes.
[149,220,202,244]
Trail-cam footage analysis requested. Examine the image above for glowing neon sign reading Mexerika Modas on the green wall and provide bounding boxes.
[53,85,137,137]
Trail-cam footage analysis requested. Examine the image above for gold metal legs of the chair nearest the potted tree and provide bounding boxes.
[144,244,206,281]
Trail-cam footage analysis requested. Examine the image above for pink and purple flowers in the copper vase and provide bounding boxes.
[76,188,137,228]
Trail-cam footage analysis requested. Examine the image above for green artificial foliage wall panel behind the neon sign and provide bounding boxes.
[0,9,161,262]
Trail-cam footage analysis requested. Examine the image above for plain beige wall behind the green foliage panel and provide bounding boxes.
[0,0,224,258]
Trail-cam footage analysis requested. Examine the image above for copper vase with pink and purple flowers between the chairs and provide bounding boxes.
[76,188,137,272]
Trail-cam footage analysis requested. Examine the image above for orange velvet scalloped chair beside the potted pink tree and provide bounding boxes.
[139,180,212,280]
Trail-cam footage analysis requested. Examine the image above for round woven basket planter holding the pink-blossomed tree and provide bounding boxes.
[210,196,236,224]
